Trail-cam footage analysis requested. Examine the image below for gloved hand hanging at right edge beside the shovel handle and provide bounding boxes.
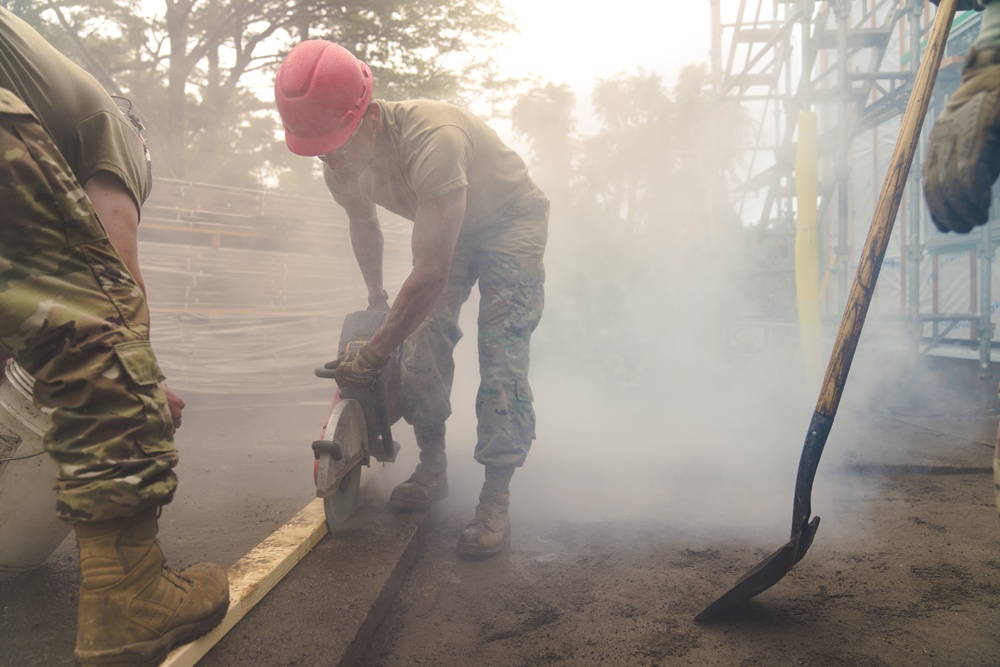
[924,46,1000,234]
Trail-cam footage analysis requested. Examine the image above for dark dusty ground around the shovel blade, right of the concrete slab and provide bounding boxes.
[365,418,1000,666]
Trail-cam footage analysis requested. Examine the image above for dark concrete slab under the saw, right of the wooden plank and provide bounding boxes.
[198,486,429,667]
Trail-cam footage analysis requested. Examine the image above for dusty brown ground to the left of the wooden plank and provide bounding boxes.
[0,395,326,667]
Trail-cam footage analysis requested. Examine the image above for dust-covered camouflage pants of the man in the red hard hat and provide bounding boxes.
[399,180,549,466]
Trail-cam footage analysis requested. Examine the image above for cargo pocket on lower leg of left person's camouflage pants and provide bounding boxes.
[115,340,174,456]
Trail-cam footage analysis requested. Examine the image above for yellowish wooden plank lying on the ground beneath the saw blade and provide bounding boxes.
[161,498,327,667]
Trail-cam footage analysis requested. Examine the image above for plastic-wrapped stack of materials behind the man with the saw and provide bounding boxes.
[139,180,410,395]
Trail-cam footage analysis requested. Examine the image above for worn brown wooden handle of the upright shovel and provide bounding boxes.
[816,0,958,417]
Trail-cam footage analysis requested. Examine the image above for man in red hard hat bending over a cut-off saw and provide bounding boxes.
[275,40,549,556]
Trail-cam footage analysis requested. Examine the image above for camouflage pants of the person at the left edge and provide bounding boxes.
[0,89,177,521]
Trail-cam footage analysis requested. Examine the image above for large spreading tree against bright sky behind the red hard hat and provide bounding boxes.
[7,0,513,186]
